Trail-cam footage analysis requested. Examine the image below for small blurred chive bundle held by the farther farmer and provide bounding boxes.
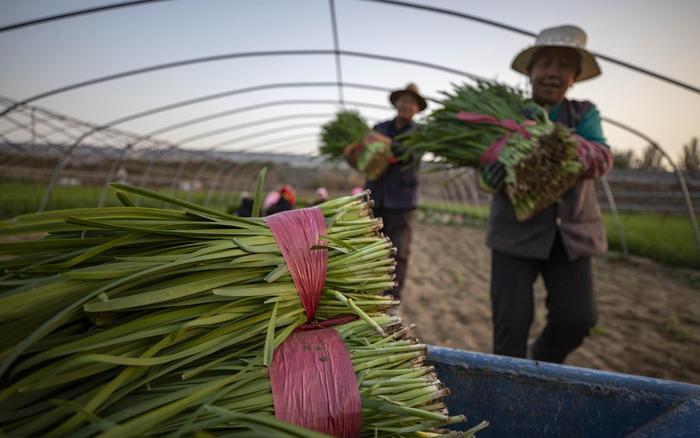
[319,111,392,181]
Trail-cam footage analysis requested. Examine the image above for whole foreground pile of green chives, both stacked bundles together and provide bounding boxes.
[0,179,482,437]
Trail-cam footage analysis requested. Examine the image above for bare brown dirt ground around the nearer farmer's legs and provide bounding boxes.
[401,224,700,384]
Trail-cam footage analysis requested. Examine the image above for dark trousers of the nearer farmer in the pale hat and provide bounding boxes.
[491,235,598,363]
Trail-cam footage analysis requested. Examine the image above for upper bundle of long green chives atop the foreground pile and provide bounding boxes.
[0,174,476,436]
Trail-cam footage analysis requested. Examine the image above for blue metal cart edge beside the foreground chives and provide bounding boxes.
[428,346,700,438]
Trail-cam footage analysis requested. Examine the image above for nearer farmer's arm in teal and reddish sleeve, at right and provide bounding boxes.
[574,105,613,178]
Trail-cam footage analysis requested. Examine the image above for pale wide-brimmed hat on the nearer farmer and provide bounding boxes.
[511,26,600,82]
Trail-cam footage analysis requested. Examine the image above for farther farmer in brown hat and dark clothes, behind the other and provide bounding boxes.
[365,84,428,298]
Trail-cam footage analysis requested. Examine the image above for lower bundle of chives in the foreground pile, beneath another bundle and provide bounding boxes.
[5,315,484,438]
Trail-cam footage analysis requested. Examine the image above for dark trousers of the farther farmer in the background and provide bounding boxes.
[374,208,413,298]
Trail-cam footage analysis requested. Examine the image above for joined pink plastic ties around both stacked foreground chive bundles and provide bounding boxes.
[265,207,362,438]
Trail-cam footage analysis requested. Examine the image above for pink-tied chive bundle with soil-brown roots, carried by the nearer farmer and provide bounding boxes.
[404,81,583,220]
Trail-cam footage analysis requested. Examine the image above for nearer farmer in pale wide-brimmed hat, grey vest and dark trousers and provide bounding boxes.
[486,26,612,363]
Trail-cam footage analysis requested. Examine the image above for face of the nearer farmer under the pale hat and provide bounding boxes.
[530,47,581,106]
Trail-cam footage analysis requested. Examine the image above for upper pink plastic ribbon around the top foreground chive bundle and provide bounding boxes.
[265,207,328,321]
